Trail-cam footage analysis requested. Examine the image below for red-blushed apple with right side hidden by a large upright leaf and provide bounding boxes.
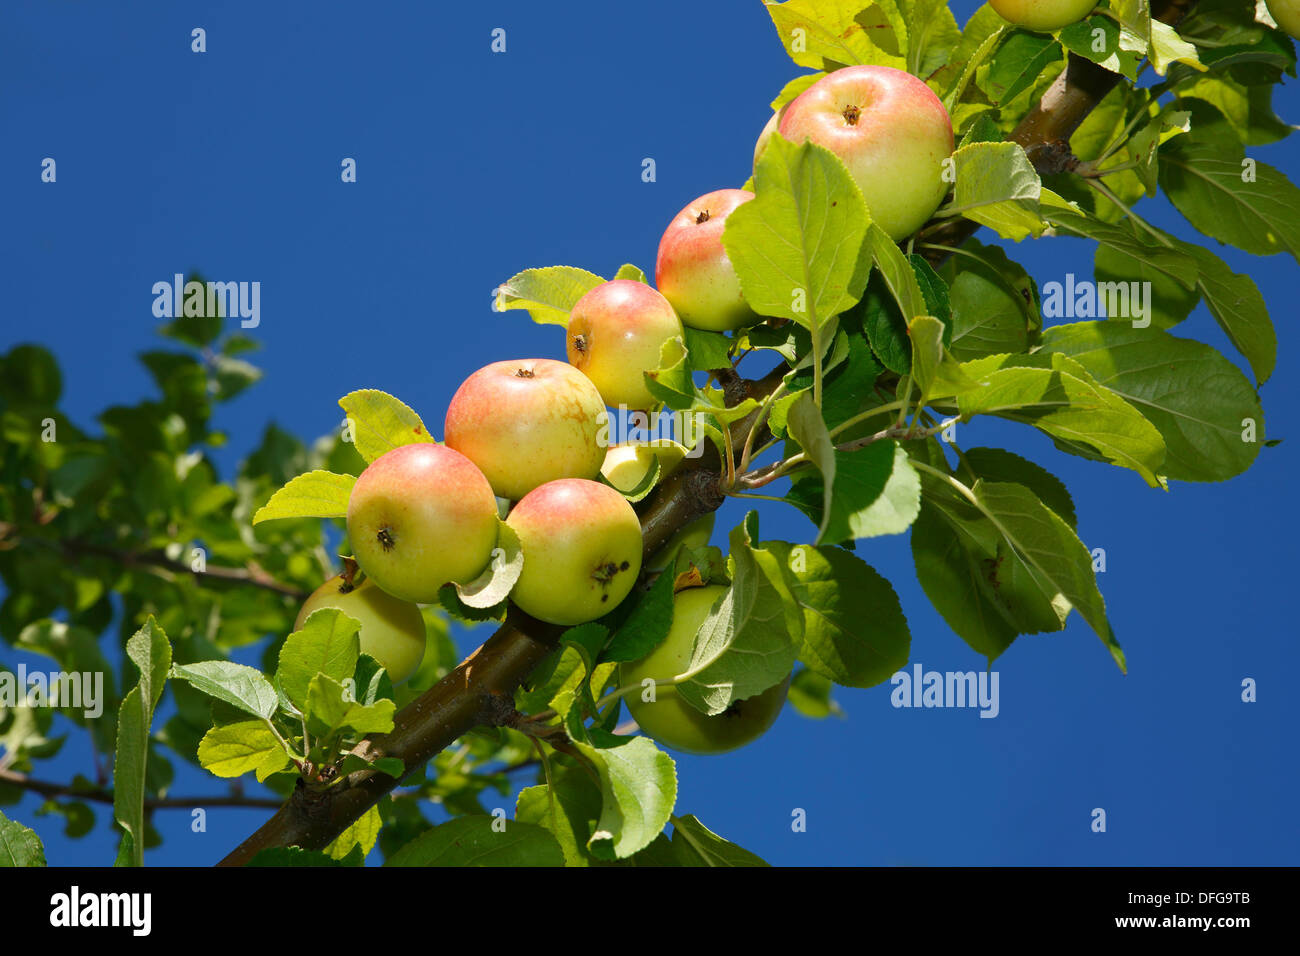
[654,189,761,332]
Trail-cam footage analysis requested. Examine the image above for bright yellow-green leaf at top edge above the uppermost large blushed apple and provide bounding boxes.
[764,0,906,70]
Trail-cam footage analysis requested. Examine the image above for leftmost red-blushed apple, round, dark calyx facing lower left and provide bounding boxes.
[347,442,498,604]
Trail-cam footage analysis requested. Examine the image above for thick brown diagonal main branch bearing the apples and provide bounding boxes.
[218,0,1195,866]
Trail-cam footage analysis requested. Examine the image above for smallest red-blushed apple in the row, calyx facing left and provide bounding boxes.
[566,278,681,408]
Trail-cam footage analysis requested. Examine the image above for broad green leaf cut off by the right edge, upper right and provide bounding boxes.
[1160,140,1300,261]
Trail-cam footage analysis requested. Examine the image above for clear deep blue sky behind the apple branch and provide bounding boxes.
[0,0,1300,865]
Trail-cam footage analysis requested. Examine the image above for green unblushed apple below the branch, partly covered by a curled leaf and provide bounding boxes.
[619,584,790,753]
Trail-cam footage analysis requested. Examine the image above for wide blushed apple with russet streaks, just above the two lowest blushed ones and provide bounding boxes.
[443,359,607,501]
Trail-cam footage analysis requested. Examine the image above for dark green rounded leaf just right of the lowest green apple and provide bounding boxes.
[768,542,911,687]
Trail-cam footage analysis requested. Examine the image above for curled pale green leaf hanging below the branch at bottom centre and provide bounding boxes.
[573,730,677,860]
